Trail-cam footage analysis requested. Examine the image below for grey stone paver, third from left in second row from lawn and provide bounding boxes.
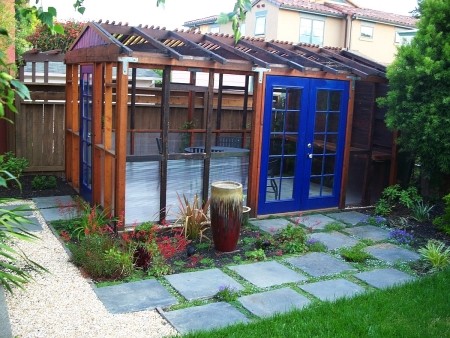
[229,261,307,288]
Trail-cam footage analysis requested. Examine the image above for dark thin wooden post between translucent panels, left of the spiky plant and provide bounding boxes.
[159,66,172,223]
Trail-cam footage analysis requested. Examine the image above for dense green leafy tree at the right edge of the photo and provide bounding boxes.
[380,0,450,182]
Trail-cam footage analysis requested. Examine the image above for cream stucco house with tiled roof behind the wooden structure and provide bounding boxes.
[184,0,417,64]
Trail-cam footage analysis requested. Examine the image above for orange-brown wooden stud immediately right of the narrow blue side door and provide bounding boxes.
[92,63,103,205]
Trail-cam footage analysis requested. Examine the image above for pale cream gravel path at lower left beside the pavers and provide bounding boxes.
[6,203,177,338]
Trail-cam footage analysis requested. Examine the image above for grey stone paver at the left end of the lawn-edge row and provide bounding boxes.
[163,302,249,334]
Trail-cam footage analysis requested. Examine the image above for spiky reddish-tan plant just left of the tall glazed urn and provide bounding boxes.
[175,194,211,242]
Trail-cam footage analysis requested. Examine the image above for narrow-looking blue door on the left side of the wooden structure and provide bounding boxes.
[80,65,93,202]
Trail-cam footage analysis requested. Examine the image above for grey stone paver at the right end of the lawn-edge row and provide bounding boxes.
[355,269,415,289]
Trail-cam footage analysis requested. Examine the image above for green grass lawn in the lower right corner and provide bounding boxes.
[184,269,450,338]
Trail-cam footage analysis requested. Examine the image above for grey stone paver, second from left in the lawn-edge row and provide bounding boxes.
[238,288,311,317]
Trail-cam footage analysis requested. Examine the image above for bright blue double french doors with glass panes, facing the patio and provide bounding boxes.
[258,76,348,214]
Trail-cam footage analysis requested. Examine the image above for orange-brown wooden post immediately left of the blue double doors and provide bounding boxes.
[247,74,266,216]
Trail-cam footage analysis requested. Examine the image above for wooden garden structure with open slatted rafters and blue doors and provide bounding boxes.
[65,22,396,227]
